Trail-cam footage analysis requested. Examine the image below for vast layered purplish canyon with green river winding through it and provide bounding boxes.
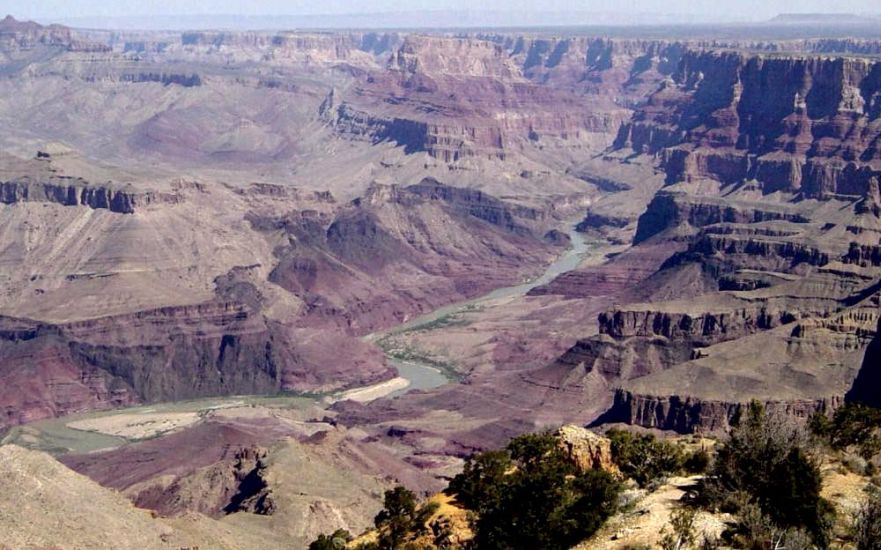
[0,10,881,547]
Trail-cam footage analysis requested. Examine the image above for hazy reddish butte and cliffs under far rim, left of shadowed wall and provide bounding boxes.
[325,35,684,162]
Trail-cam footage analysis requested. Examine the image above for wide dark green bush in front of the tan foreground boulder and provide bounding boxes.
[450,434,621,550]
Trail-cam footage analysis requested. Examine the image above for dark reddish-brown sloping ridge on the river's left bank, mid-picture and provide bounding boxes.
[260,179,560,335]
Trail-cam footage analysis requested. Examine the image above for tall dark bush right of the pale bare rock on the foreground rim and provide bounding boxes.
[701,403,834,548]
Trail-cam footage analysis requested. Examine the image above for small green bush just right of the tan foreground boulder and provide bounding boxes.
[606,430,685,487]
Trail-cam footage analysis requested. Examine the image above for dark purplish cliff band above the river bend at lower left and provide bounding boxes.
[0,294,393,427]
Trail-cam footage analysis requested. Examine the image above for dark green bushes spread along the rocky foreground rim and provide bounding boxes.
[310,403,881,550]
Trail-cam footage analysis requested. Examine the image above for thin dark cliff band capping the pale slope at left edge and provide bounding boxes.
[0,177,182,214]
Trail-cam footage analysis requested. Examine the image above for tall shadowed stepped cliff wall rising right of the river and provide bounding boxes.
[540,43,881,432]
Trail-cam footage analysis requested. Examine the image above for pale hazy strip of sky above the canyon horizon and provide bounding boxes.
[0,0,881,20]
